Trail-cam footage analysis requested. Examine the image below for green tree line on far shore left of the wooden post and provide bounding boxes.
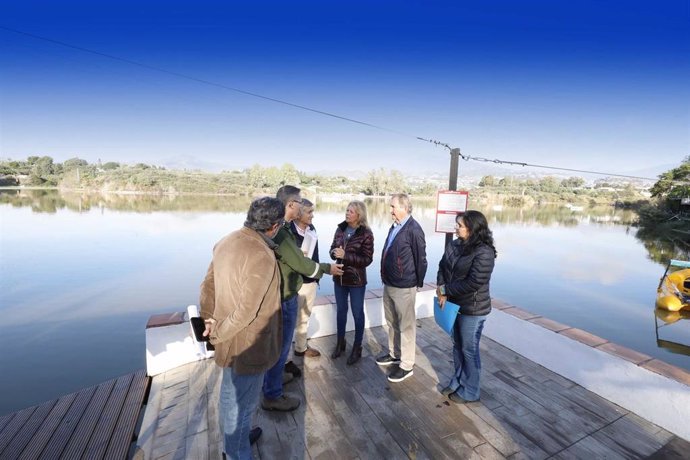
[0,156,438,196]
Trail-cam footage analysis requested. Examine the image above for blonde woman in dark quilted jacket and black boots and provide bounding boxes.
[330,201,374,364]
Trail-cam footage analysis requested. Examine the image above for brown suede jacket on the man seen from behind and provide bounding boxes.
[200,227,283,375]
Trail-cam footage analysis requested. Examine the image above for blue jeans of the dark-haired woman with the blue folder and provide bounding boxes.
[448,314,489,401]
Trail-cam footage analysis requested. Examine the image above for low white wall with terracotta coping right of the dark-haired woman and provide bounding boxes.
[484,309,690,440]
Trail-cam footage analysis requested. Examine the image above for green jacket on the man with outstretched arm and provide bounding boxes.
[273,224,331,301]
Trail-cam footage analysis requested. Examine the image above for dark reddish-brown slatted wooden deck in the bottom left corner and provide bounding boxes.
[0,370,149,460]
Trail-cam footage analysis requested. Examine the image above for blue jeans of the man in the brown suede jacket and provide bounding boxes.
[218,367,263,459]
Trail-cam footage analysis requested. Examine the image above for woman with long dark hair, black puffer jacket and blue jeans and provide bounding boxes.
[436,211,496,404]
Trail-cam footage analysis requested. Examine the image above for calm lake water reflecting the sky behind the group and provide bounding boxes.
[0,191,690,415]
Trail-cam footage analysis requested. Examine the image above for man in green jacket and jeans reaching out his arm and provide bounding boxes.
[261,185,343,411]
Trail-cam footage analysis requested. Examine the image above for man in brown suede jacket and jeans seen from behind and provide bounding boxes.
[200,197,285,459]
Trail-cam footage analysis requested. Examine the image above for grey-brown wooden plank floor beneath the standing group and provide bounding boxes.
[136,318,690,460]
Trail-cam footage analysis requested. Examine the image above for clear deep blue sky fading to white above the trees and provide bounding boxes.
[0,0,690,173]
